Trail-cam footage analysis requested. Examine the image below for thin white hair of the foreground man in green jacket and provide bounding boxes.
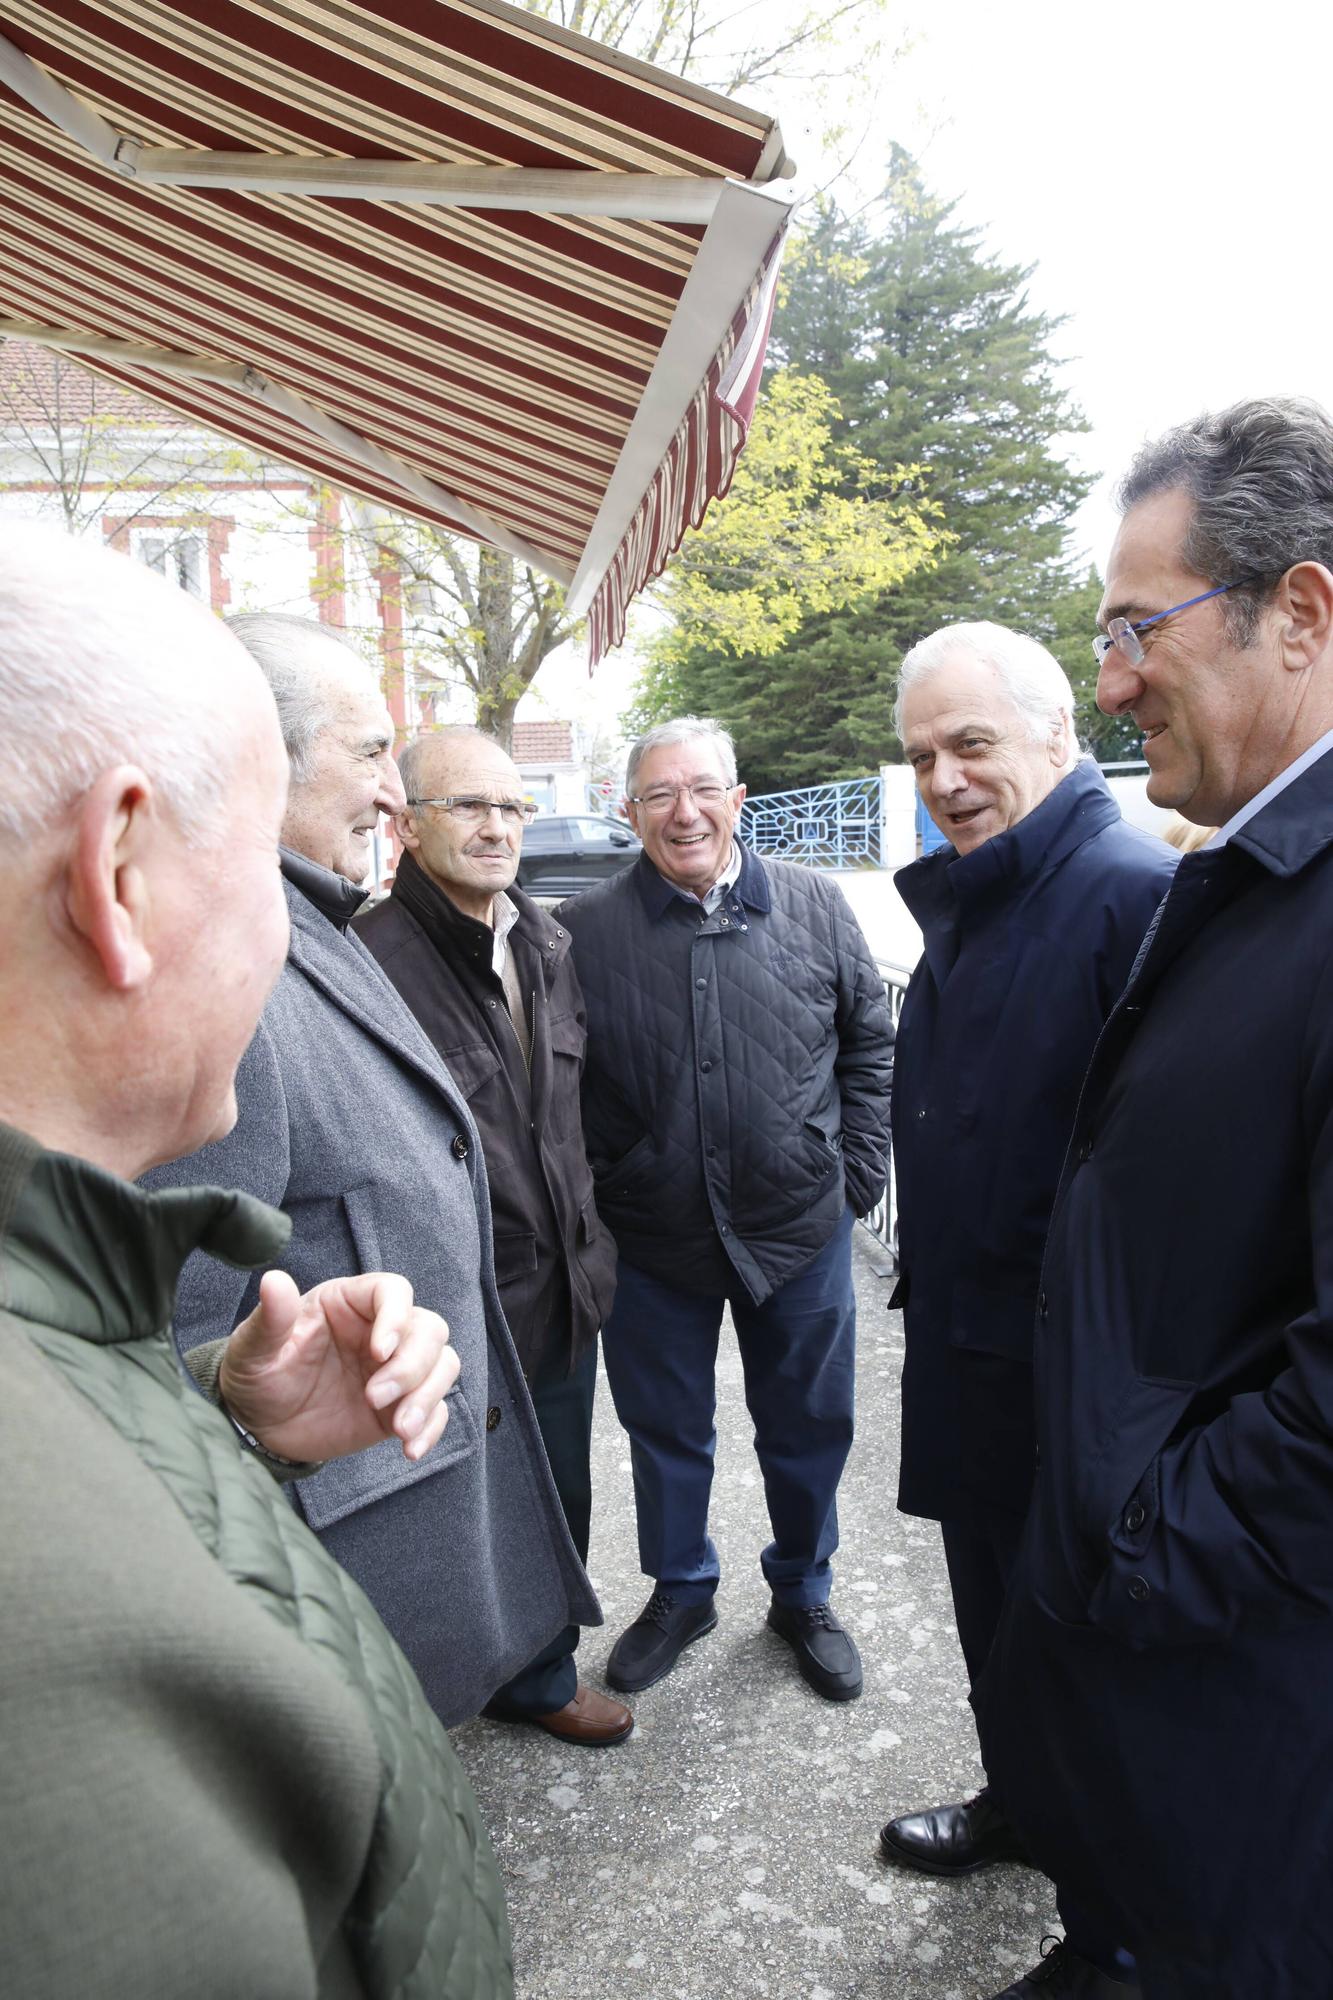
[0,522,248,846]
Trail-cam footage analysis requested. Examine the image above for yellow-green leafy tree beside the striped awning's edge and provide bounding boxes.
[628,370,951,790]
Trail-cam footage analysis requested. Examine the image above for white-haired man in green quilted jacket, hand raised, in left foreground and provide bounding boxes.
[0,522,512,2000]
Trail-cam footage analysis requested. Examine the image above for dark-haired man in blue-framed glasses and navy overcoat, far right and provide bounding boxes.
[979,400,1333,2000]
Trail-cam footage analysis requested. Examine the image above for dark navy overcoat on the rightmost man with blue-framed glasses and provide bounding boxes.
[979,752,1333,2000]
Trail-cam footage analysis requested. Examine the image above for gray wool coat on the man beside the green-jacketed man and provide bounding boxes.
[148,880,600,1724]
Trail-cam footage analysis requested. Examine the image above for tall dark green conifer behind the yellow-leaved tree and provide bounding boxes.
[677,146,1091,784]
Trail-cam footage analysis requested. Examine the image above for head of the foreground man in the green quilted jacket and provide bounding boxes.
[0,526,286,1176]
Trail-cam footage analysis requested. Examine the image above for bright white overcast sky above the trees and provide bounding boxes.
[548,0,1333,714]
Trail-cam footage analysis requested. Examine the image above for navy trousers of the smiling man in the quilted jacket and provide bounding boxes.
[602,1208,857,1606]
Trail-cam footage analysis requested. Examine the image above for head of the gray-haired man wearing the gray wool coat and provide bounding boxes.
[230,612,402,882]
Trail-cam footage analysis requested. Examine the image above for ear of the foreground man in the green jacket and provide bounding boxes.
[66,764,160,992]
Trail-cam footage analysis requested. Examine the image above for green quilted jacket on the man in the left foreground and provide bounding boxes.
[0,1126,512,2000]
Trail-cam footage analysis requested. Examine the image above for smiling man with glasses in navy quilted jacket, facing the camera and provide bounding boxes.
[558,716,893,1702]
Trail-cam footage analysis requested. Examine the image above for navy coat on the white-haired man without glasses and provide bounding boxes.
[893,762,1177,1520]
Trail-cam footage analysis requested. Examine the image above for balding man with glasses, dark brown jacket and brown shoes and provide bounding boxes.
[352,728,634,1746]
